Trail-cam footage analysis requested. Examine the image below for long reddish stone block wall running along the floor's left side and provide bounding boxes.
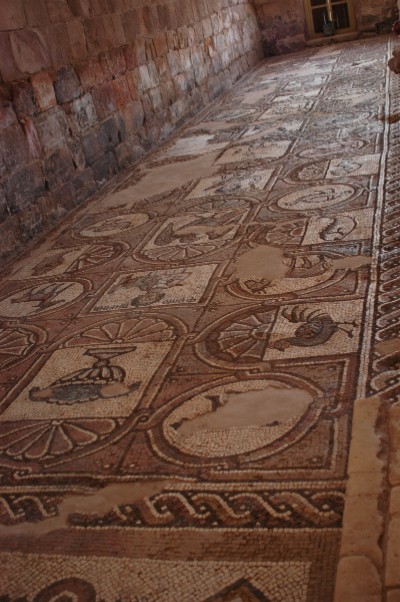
[0,0,261,259]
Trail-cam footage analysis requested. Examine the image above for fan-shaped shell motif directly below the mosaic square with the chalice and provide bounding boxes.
[0,418,118,461]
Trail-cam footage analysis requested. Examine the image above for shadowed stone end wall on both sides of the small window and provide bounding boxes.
[253,0,397,55]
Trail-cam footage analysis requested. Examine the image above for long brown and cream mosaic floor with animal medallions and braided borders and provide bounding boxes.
[0,37,399,602]
